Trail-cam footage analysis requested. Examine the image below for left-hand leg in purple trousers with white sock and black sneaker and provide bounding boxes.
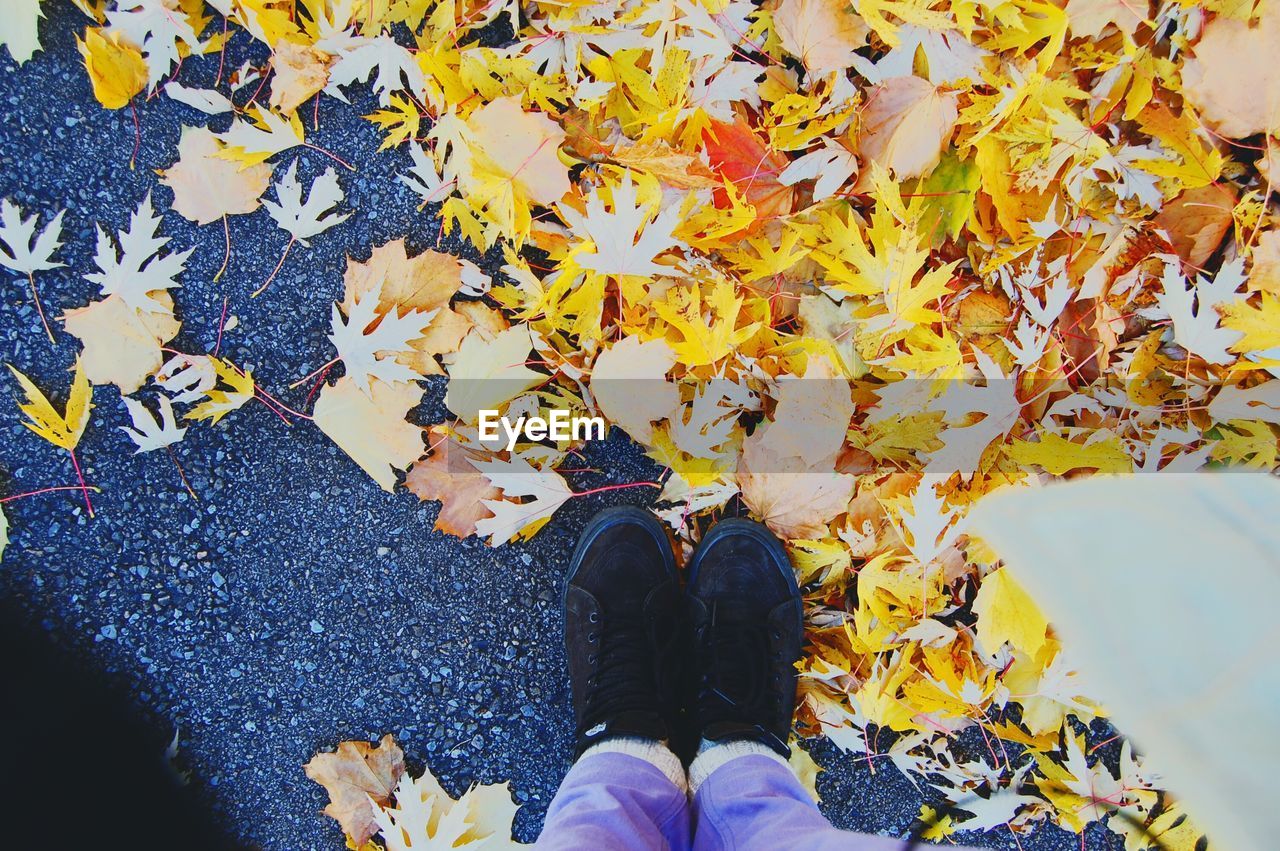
[538,508,690,850]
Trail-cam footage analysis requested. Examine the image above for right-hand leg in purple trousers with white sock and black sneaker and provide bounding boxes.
[686,520,901,851]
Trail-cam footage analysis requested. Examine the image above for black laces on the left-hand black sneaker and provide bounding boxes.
[582,613,659,728]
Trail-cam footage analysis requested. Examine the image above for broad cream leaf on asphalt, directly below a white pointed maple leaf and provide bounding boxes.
[312,375,422,493]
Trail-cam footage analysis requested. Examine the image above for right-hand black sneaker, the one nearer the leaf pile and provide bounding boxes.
[685,518,804,756]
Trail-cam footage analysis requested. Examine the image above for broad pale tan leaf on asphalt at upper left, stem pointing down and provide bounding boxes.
[160,127,271,224]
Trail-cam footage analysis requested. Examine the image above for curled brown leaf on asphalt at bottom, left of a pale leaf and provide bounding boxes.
[302,733,404,846]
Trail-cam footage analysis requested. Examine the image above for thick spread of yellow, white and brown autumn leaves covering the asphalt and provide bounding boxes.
[0,0,1280,851]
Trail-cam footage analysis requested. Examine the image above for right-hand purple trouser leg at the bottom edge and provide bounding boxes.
[692,755,906,851]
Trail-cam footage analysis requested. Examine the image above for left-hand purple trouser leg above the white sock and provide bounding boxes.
[535,754,689,851]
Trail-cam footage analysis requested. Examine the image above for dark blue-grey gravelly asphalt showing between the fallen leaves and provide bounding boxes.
[0,3,1119,850]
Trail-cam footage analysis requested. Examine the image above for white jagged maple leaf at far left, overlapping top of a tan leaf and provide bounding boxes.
[84,192,195,314]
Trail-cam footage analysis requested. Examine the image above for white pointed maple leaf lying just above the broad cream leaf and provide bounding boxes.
[329,283,436,393]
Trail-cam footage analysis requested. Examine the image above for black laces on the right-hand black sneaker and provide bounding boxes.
[698,604,780,732]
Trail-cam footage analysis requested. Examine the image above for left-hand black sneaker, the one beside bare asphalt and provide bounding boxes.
[564,505,682,758]
